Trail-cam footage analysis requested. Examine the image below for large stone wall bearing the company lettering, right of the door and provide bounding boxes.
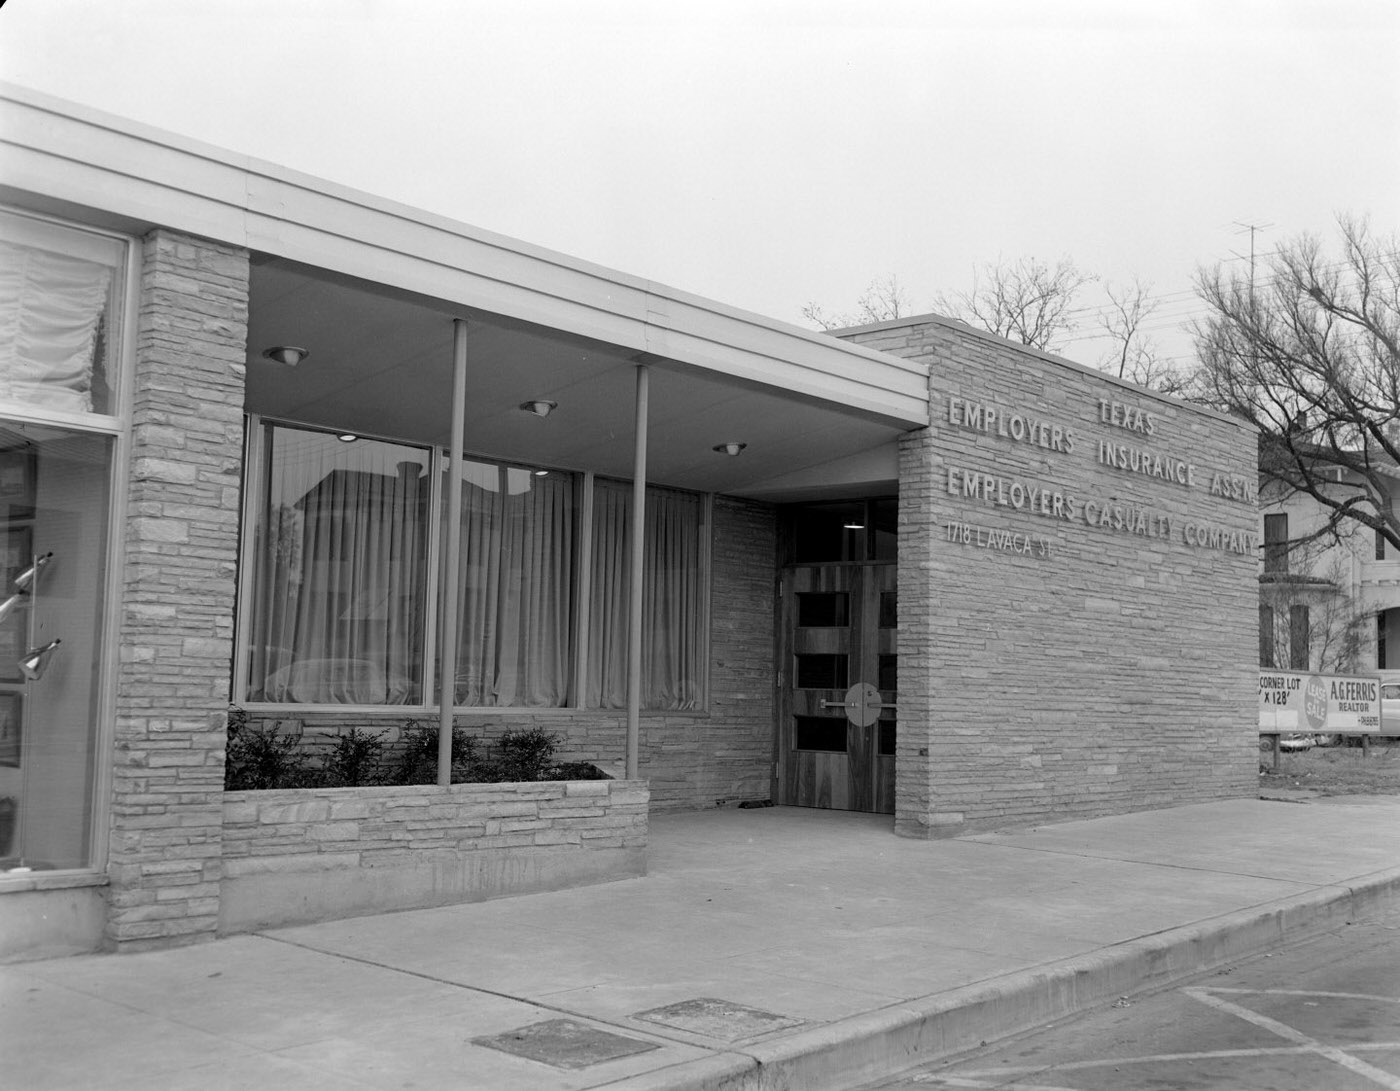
[843,319,1259,836]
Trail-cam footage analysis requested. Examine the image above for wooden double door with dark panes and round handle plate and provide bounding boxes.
[776,563,897,814]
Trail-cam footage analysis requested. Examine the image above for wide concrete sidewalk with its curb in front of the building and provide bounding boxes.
[8,797,1400,1091]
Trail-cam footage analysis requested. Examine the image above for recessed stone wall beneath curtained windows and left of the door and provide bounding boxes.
[235,497,777,811]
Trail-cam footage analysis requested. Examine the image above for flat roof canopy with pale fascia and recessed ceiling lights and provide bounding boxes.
[0,84,928,500]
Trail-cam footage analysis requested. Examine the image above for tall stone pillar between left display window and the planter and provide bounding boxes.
[106,230,248,950]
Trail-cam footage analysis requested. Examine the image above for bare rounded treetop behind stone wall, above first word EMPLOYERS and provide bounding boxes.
[934,258,1098,352]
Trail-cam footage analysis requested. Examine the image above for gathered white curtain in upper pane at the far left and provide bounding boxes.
[0,242,112,413]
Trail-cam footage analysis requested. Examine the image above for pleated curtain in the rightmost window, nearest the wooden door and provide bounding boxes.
[585,480,704,710]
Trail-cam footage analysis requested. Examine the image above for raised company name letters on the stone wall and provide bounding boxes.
[944,398,1259,553]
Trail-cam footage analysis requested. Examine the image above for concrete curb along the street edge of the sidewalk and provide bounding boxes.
[596,868,1400,1091]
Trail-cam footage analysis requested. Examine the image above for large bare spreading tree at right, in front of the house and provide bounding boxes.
[1194,217,1400,549]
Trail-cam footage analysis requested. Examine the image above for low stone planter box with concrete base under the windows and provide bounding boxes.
[218,780,650,934]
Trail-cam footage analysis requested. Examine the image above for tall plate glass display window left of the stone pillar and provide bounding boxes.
[0,204,129,874]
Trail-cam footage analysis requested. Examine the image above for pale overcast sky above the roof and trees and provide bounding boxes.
[0,0,1400,363]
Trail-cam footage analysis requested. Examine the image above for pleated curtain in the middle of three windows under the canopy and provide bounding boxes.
[454,462,575,707]
